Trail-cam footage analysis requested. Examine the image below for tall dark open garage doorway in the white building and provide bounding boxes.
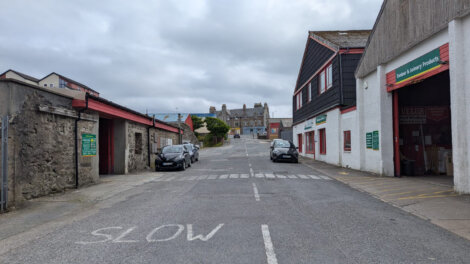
[393,70,453,180]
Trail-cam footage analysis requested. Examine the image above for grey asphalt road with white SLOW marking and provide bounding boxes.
[0,138,470,264]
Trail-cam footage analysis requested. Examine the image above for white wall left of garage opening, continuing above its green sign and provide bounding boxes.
[356,27,449,176]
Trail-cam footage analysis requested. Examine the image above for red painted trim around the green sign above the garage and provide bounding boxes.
[386,43,449,92]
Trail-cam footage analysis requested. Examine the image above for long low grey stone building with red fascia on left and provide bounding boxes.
[0,78,178,206]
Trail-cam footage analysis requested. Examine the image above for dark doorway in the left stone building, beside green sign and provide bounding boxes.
[98,118,114,174]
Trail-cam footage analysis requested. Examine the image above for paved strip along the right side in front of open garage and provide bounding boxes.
[301,157,470,240]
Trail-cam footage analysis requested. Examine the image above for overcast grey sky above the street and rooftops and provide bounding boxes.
[0,0,382,117]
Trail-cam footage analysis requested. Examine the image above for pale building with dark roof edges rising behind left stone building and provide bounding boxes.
[0,69,100,96]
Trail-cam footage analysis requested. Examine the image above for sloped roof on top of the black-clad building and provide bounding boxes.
[309,30,371,49]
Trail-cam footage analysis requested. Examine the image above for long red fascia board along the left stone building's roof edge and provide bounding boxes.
[72,99,178,133]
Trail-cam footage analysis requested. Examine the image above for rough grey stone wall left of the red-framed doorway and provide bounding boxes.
[0,81,99,205]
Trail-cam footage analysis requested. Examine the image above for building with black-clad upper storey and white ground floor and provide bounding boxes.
[293,30,370,166]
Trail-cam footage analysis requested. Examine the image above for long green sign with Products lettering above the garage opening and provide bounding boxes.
[395,48,441,83]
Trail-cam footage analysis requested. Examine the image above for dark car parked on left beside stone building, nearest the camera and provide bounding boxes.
[155,145,191,171]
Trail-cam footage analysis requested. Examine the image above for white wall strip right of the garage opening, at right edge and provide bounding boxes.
[449,15,470,193]
